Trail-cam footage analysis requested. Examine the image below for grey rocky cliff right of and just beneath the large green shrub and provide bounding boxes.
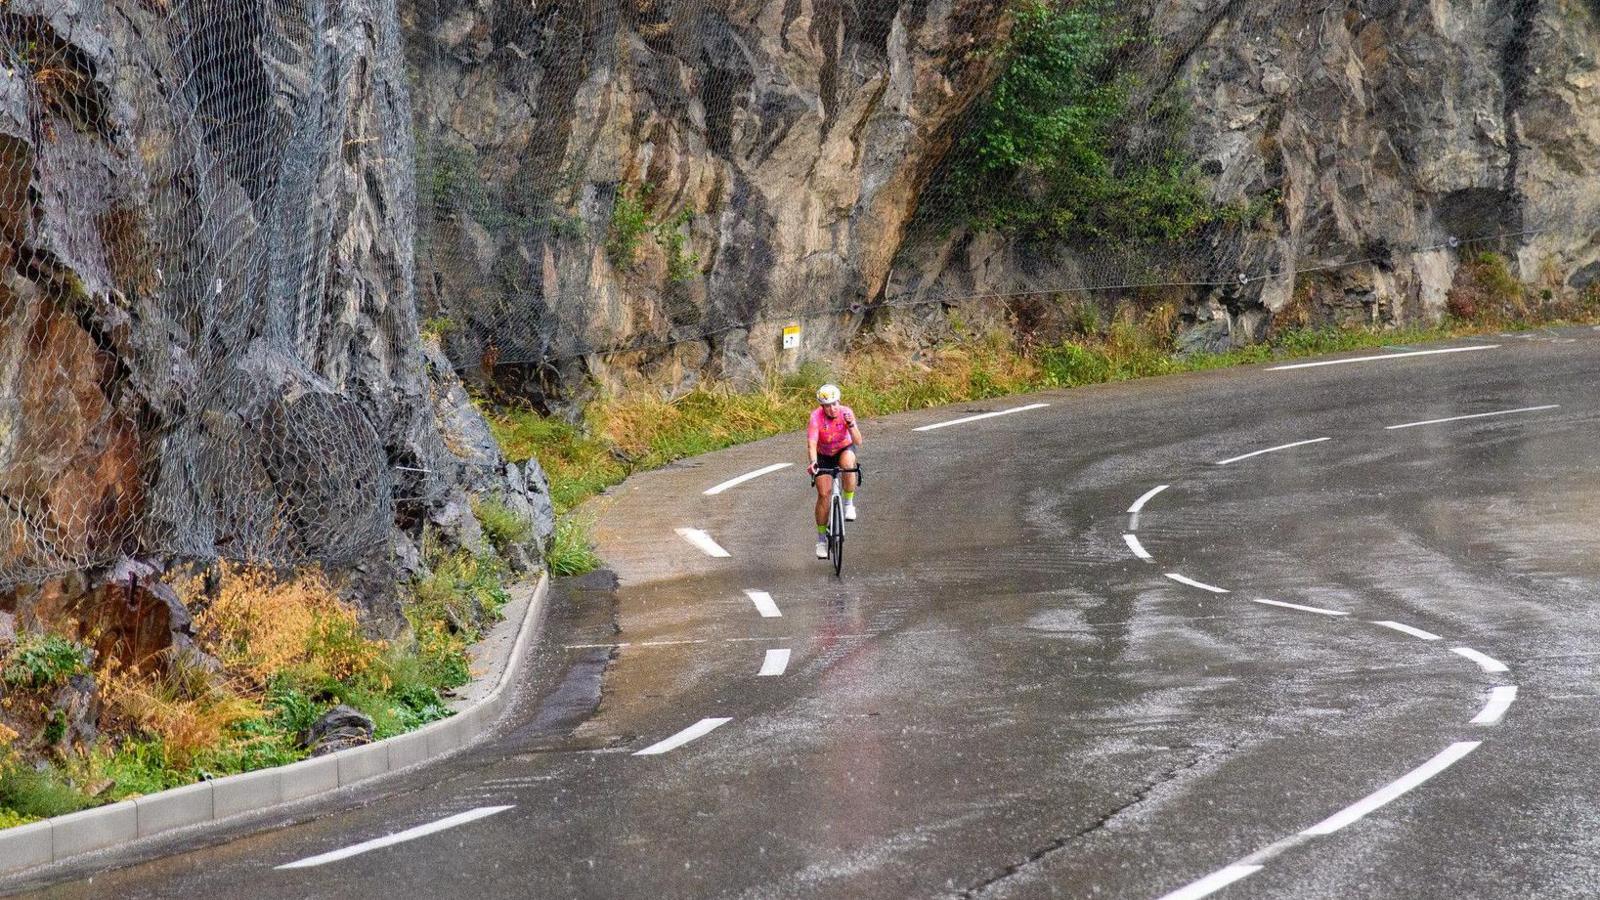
[891,0,1600,346]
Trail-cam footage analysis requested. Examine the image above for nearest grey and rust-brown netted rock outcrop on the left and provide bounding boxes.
[0,0,549,634]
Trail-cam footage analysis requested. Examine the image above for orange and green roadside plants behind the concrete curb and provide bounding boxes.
[0,531,530,828]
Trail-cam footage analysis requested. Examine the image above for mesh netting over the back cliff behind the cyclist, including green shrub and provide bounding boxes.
[408,0,1600,391]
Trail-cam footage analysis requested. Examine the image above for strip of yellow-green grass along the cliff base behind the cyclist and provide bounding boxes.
[485,269,1600,560]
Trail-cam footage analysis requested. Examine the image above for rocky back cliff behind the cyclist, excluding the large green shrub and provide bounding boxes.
[406,0,1600,381]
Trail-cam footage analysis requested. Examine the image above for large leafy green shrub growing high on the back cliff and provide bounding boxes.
[923,0,1228,243]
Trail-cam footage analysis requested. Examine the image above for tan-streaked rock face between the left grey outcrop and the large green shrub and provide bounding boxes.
[406,0,1006,394]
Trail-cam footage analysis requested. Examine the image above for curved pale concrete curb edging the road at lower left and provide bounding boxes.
[0,575,550,876]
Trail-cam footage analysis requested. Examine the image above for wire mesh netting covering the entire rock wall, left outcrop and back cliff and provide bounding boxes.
[0,0,1600,588]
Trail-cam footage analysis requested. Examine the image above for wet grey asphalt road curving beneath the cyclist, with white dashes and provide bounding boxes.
[5,330,1600,898]
